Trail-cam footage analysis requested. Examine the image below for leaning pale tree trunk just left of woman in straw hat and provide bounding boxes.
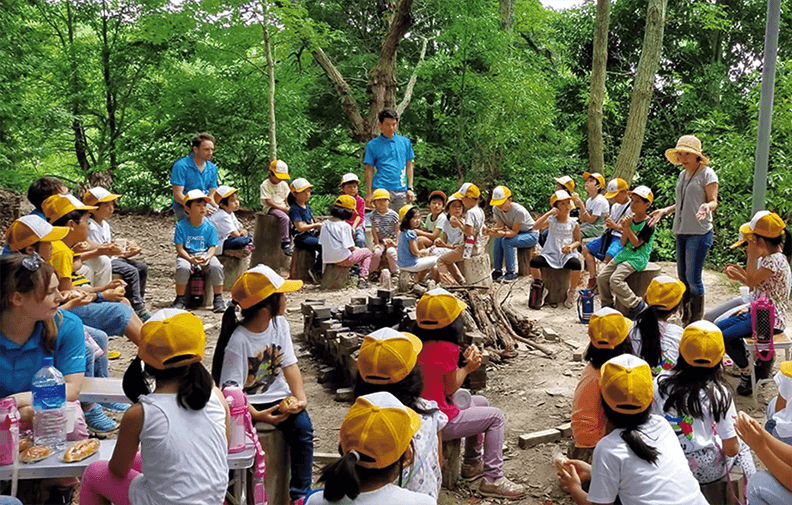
[613,0,666,183]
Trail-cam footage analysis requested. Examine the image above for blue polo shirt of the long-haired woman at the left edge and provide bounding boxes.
[0,310,85,398]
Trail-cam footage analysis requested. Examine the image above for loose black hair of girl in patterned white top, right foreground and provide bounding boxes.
[657,356,732,422]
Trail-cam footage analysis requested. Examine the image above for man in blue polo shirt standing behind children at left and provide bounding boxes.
[171,133,217,221]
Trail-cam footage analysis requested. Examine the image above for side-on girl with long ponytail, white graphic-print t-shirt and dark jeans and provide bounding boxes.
[212,265,313,501]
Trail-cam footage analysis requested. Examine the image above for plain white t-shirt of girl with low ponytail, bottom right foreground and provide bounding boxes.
[588,415,708,505]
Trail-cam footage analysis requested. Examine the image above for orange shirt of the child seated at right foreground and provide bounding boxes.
[572,363,605,448]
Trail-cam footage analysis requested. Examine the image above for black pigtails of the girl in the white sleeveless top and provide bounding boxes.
[121,356,214,410]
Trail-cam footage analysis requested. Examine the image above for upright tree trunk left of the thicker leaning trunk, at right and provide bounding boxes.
[588,0,610,174]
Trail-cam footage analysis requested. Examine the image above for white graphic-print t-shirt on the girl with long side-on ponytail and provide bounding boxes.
[220,316,297,403]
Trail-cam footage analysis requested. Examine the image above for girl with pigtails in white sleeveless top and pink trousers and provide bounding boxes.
[80,309,230,505]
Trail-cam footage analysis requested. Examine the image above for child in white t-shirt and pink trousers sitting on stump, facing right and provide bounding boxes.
[319,195,374,289]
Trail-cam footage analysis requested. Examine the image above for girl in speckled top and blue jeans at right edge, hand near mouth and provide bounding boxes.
[717,210,792,396]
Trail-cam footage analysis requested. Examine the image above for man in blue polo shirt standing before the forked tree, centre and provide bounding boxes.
[363,109,415,212]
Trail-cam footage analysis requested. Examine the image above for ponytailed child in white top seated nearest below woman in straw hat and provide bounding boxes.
[630,275,685,375]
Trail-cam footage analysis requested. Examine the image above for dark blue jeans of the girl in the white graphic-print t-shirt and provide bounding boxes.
[254,400,313,500]
